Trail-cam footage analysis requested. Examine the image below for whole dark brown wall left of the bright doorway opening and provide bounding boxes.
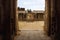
[0,0,17,40]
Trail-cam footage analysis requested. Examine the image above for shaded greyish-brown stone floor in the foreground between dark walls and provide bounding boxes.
[15,30,51,40]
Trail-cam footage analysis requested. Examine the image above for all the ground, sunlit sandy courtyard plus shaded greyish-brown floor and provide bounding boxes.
[15,21,51,40]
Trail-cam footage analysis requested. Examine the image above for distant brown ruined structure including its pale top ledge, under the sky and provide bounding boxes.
[18,10,44,21]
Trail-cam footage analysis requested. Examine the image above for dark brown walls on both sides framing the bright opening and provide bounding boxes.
[0,0,60,40]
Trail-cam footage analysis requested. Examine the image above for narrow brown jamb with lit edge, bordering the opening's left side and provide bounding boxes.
[10,0,18,35]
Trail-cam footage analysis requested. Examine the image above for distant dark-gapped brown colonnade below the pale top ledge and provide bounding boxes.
[18,13,44,21]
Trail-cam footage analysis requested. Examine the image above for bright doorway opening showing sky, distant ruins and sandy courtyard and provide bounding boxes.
[17,0,45,30]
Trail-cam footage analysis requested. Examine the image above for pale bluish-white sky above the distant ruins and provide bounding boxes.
[17,0,45,10]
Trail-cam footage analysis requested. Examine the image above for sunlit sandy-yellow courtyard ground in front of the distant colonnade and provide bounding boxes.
[18,21,44,30]
